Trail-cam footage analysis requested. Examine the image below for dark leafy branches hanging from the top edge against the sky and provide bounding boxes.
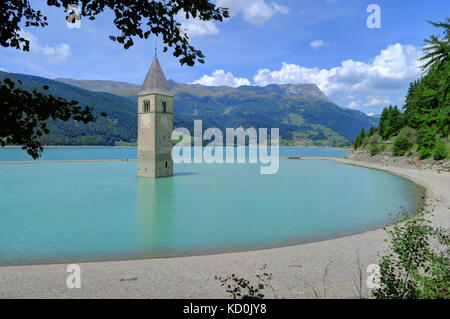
[0,0,229,66]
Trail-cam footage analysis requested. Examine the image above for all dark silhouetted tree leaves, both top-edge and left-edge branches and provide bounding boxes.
[0,0,229,158]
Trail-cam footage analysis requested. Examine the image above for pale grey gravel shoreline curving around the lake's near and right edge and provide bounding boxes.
[0,159,450,298]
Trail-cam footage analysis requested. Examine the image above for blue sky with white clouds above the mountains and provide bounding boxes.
[0,0,450,114]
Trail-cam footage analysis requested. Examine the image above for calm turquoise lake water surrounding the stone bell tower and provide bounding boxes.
[0,149,423,265]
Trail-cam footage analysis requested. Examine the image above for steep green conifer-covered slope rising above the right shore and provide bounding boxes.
[354,19,450,160]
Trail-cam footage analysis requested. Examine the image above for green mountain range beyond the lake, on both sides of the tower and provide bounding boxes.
[0,72,378,146]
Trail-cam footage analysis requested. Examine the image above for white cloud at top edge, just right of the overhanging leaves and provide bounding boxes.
[217,0,289,25]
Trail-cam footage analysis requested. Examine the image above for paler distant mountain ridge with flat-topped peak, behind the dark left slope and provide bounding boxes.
[53,79,377,145]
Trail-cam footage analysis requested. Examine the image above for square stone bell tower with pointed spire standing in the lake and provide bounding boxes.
[138,55,173,178]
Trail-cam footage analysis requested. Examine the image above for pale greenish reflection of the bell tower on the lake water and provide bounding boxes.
[138,178,176,257]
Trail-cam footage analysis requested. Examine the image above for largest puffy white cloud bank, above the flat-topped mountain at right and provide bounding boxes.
[253,43,421,108]
